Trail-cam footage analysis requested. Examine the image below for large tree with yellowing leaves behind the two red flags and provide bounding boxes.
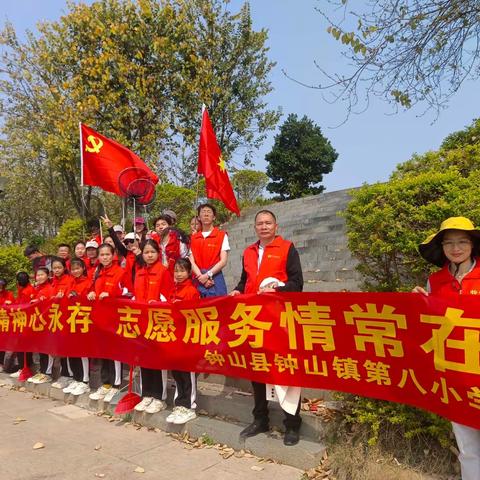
[0,0,278,228]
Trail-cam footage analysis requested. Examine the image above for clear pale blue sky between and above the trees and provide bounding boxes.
[0,0,479,191]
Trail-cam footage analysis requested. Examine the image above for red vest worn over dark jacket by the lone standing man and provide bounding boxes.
[243,236,292,293]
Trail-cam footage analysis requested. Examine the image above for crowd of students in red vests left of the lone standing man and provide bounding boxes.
[0,204,221,424]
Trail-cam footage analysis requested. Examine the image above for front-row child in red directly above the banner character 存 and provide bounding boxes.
[62,258,92,397]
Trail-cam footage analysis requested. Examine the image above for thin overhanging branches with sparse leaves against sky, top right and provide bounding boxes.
[313,0,480,112]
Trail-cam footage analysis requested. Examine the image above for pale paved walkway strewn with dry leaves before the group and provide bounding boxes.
[0,386,303,480]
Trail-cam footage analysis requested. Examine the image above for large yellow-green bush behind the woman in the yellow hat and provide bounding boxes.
[345,119,480,291]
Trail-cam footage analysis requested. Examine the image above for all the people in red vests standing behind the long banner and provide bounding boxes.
[0,204,480,470]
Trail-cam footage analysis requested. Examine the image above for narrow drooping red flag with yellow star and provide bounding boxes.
[197,108,240,215]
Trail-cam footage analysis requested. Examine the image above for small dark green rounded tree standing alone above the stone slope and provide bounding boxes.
[265,114,338,200]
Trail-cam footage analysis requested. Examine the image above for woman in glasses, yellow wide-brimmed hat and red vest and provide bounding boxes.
[413,217,480,480]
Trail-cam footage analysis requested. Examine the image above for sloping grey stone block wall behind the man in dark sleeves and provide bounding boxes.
[224,189,361,292]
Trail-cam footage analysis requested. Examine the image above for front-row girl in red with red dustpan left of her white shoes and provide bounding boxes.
[134,239,173,413]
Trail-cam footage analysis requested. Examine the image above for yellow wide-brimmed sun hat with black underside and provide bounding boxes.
[418,217,480,267]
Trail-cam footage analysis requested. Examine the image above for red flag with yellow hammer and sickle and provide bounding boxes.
[80,124,158,197]
